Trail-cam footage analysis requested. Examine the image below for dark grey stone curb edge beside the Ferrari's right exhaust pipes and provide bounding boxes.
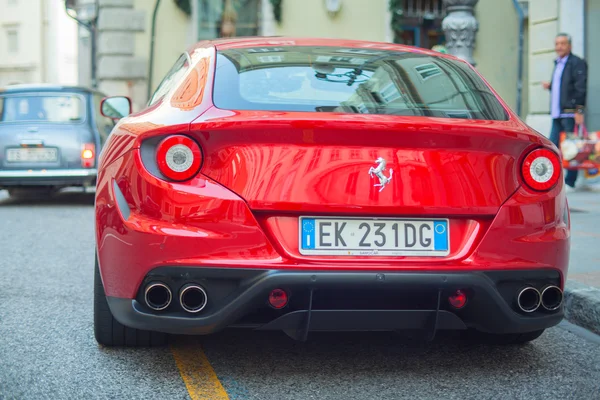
[564,280,600,335]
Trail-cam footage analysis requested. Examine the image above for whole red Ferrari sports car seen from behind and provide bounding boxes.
[94,37,570,346]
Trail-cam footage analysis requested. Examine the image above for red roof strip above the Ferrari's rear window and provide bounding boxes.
[193,36,460,60]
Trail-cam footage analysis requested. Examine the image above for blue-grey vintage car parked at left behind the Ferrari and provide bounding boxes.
[0,84,114,196]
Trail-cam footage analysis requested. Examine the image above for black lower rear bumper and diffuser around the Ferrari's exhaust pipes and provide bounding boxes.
[107,267,563,338]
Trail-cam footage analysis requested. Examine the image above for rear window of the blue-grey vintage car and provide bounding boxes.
[0,94,85,123]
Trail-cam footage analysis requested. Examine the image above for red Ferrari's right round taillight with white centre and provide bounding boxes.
[522,149,561,191]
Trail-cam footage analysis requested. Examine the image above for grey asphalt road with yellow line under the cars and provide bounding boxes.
[0,188,600,400]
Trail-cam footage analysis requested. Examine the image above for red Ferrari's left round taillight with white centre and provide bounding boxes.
[156,135,202,181]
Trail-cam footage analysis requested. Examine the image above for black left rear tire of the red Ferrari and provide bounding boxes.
[94,257,168,347]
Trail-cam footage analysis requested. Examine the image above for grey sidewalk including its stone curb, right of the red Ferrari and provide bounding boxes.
[565,185,600,334]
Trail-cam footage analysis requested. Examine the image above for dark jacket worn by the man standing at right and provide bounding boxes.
[550,53,587,114]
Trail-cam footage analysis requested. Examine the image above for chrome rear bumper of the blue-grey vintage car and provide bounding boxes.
[0,168,98,187]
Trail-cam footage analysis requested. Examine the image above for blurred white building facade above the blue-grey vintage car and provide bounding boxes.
[0,0,77,87]
